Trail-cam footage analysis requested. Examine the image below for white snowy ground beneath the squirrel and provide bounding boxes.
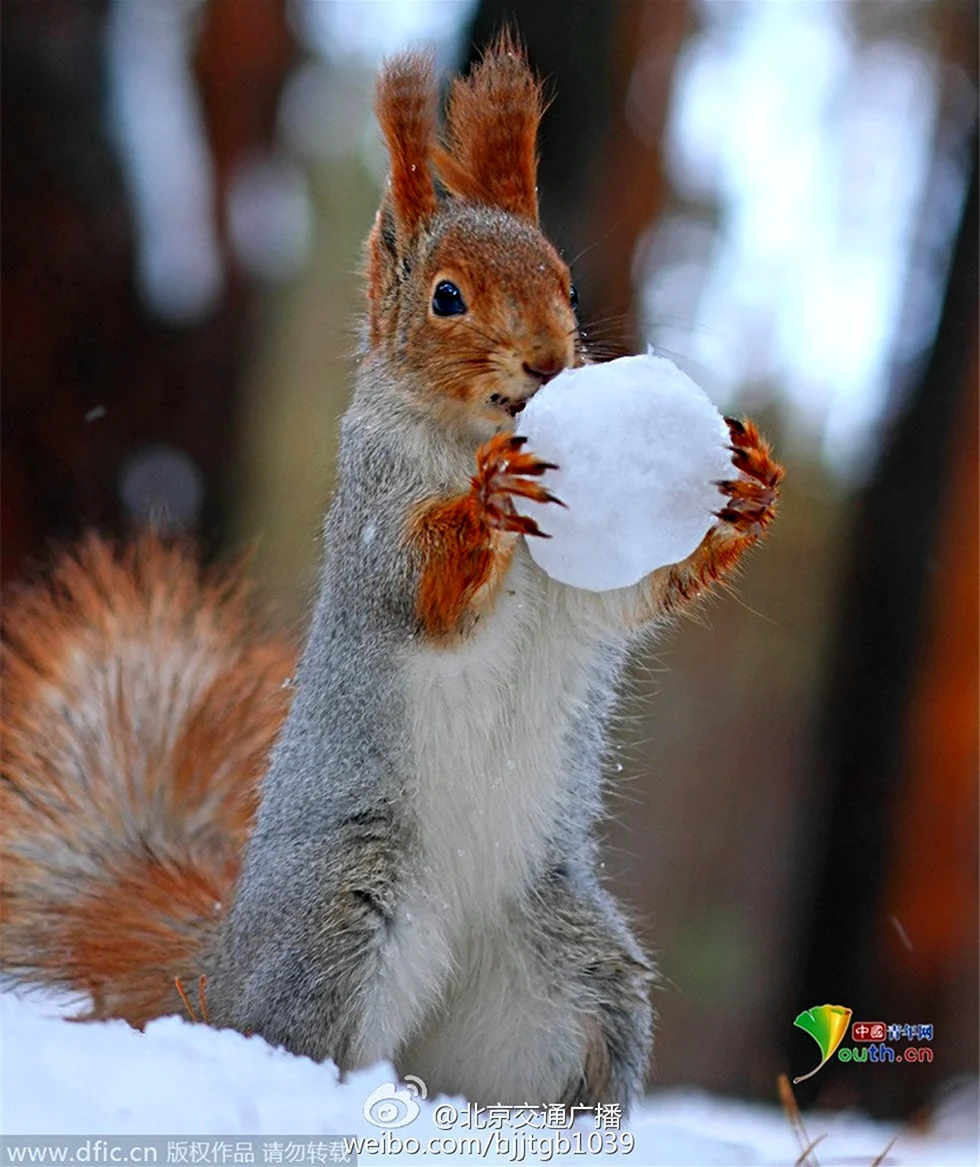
[0,993,978,1167]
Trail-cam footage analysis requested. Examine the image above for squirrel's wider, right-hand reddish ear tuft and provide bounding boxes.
[435,29,544,223]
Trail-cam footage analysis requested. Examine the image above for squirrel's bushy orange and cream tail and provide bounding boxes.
[0,533,295,1026]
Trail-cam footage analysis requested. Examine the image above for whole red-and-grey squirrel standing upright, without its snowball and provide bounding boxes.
[0,33,782,1109]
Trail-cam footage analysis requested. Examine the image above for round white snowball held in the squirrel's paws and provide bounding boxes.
[515,355,734,592]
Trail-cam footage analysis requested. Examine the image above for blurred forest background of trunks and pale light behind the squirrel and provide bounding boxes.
[0,0,980,1114]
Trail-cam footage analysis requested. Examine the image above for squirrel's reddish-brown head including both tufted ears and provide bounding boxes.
[368,33,581,438]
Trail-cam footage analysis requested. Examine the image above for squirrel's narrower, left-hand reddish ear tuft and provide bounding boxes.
[375,53,439,238]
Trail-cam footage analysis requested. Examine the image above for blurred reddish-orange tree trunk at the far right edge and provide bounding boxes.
[872,331,980,1112]
